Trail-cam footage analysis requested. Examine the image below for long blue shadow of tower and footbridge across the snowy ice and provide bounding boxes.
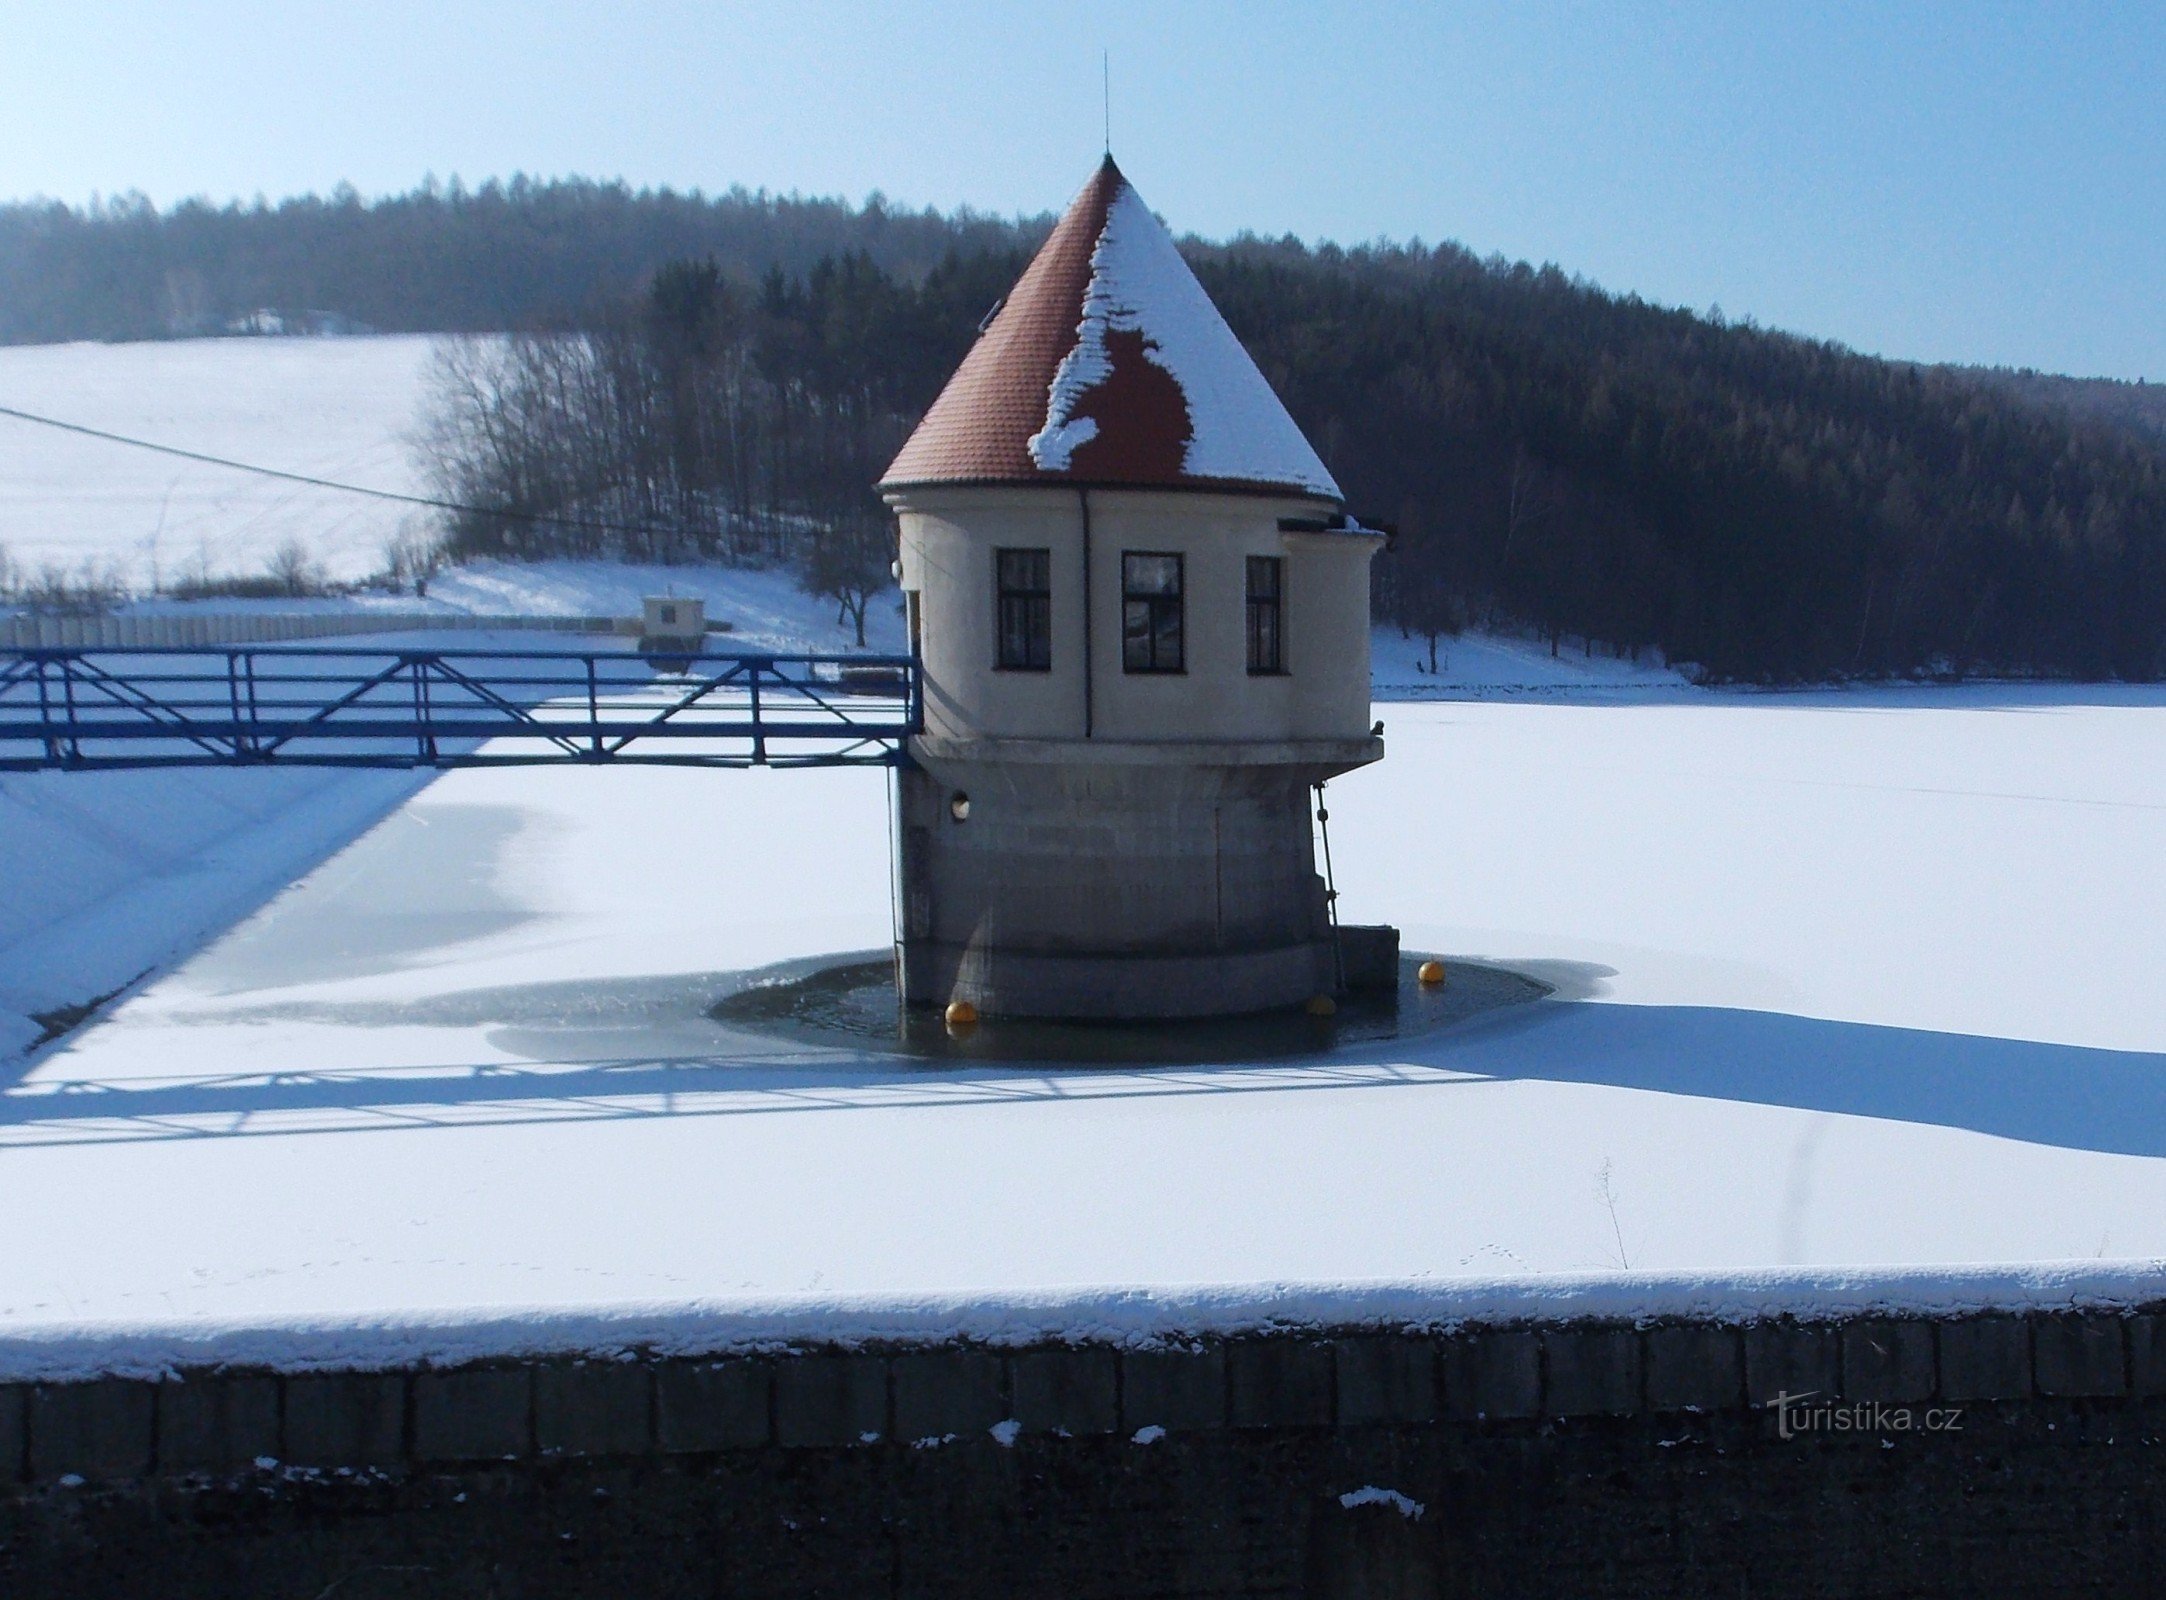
[0,963,2166,1156]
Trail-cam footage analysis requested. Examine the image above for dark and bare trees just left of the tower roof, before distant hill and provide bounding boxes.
[425,251,1025,645]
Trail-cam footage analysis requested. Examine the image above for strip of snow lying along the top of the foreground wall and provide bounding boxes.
[0,1260,2166,1385]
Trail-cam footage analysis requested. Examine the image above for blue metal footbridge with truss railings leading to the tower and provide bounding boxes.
[0,645,923,771]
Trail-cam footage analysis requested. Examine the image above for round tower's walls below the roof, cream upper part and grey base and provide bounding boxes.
[890,487,1382,1018]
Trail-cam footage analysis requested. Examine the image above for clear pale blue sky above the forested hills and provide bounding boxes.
[0,0,2166,381]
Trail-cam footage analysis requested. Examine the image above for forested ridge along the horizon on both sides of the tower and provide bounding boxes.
[12,184,2166,680]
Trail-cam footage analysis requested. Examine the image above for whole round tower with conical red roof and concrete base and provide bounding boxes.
[882,158,1384,1018]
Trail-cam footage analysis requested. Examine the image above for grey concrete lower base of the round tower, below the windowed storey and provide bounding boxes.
[899,738,1380,1020]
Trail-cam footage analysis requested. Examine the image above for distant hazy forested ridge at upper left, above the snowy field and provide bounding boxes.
[0,178,1053,344]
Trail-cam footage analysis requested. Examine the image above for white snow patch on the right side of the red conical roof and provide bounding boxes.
[1029,184,1341,500]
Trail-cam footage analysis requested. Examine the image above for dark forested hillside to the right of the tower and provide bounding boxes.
[1198,245,2166,680]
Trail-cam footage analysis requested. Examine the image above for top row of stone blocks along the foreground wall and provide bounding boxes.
[0,1312,2166,1485]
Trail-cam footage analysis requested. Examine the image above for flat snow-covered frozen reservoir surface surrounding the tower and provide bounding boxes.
[0,688,2166,1373]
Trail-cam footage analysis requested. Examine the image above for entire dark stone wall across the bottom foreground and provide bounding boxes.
[0,1312,2166,1600]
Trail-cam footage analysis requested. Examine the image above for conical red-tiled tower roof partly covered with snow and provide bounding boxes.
[882,156,1345,500]
